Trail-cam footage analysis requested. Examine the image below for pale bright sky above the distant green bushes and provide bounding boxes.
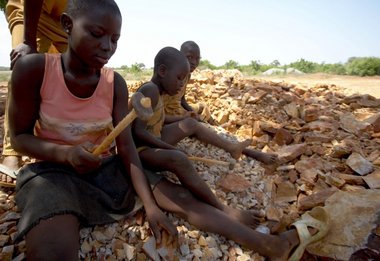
[0,0,380,67]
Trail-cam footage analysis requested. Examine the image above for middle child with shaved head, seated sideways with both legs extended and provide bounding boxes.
[132,47,260,227]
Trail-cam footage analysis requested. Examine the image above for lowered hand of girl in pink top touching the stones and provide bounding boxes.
[145,207,178,245]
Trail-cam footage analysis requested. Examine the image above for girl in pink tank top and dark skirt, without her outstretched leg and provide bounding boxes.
[9,0,177,260]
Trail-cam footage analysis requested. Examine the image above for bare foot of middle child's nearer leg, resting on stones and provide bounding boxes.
[223,206,265,229]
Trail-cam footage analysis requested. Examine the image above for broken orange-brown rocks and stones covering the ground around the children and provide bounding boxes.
[0,70,380,261]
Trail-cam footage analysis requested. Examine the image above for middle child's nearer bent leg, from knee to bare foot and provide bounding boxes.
[139,148,261,228]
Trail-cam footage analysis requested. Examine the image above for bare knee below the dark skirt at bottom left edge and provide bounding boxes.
[26,215,79,261]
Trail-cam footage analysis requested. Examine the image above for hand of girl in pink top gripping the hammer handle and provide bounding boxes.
[67,142,101,174]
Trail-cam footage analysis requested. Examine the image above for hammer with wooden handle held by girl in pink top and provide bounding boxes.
[92,92,153,155]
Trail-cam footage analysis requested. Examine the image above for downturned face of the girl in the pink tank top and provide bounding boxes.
[69,9,122,69]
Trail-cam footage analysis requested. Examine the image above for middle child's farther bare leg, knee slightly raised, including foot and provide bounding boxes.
[161,118,251,159]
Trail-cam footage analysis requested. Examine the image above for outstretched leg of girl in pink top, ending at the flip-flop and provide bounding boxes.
[153,180,299,260]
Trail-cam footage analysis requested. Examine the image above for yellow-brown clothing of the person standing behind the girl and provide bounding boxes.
[3,0,67,156]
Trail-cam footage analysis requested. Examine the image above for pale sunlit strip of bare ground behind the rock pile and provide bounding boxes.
[254,74,380,99]
